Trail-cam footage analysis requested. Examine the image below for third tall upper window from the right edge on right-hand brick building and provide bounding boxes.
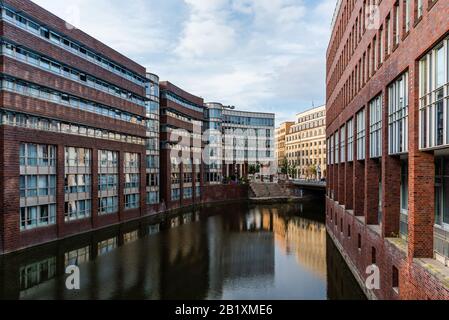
[369,95,382,158]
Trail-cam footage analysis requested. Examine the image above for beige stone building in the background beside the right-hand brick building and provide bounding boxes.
[285,106,326,179]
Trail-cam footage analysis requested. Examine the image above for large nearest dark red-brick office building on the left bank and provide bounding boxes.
[0,0,154,252]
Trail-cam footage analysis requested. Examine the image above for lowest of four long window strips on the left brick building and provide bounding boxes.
[0,110,145,145]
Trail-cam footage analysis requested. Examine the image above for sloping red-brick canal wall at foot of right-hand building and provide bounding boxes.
[326,197,449,300]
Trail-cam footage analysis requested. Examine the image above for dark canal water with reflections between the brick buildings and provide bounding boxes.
[0,199,364,300]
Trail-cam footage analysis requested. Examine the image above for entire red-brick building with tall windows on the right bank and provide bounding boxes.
[326,0,449,299]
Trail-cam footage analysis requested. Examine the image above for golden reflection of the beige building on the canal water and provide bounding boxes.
[273,209,326,279]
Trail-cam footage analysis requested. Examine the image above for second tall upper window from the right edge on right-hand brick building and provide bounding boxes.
[388,72,408,154]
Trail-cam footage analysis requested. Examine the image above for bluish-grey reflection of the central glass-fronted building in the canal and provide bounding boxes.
[207,208,275,299]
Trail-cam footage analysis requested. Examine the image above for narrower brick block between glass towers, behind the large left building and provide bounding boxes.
[160,82,205,209]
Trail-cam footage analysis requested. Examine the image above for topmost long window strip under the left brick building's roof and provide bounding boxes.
[0,4,148,86]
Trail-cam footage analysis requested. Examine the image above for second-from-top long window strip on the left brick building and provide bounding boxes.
[0,40,145,106]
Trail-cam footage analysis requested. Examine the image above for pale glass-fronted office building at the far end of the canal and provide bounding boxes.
[202,102,277,180]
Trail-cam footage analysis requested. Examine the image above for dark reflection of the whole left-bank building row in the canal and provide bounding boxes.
[0,204,275,300]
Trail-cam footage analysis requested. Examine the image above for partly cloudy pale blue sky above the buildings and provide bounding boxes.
[33,0,336,124]
